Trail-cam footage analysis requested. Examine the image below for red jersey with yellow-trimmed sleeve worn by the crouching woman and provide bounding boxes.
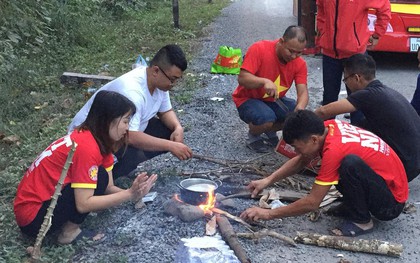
[14,131,114,226]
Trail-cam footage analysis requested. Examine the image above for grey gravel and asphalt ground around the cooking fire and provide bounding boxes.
[74,0,420,263]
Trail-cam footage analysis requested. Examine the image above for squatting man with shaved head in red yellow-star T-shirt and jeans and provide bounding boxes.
[232,26,309,152]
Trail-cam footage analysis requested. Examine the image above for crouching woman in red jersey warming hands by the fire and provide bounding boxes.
[14,91,157,244]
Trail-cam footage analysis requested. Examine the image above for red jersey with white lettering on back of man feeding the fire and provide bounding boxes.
[315,120,408,203]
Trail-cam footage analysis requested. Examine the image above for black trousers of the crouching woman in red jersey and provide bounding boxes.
[20,174,109,237]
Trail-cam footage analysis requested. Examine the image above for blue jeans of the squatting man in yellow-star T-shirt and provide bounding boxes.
[238,97,296,126]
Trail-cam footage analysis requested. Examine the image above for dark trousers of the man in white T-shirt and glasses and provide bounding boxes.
[109,118,172,178]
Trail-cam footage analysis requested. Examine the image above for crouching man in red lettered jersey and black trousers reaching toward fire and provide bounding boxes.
[241,110,408,236]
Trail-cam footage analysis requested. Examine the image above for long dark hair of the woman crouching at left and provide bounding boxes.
[79,90,136,154]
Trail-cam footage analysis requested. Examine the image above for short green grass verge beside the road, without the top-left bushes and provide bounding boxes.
[0,0,230,262]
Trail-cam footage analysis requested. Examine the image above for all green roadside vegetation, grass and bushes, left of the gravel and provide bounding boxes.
[0,0,230,262]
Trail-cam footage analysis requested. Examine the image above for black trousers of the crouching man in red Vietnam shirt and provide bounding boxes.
[337,155,404,224]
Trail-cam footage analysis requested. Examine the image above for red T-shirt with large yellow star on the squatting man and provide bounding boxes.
[232,40,308,107]
